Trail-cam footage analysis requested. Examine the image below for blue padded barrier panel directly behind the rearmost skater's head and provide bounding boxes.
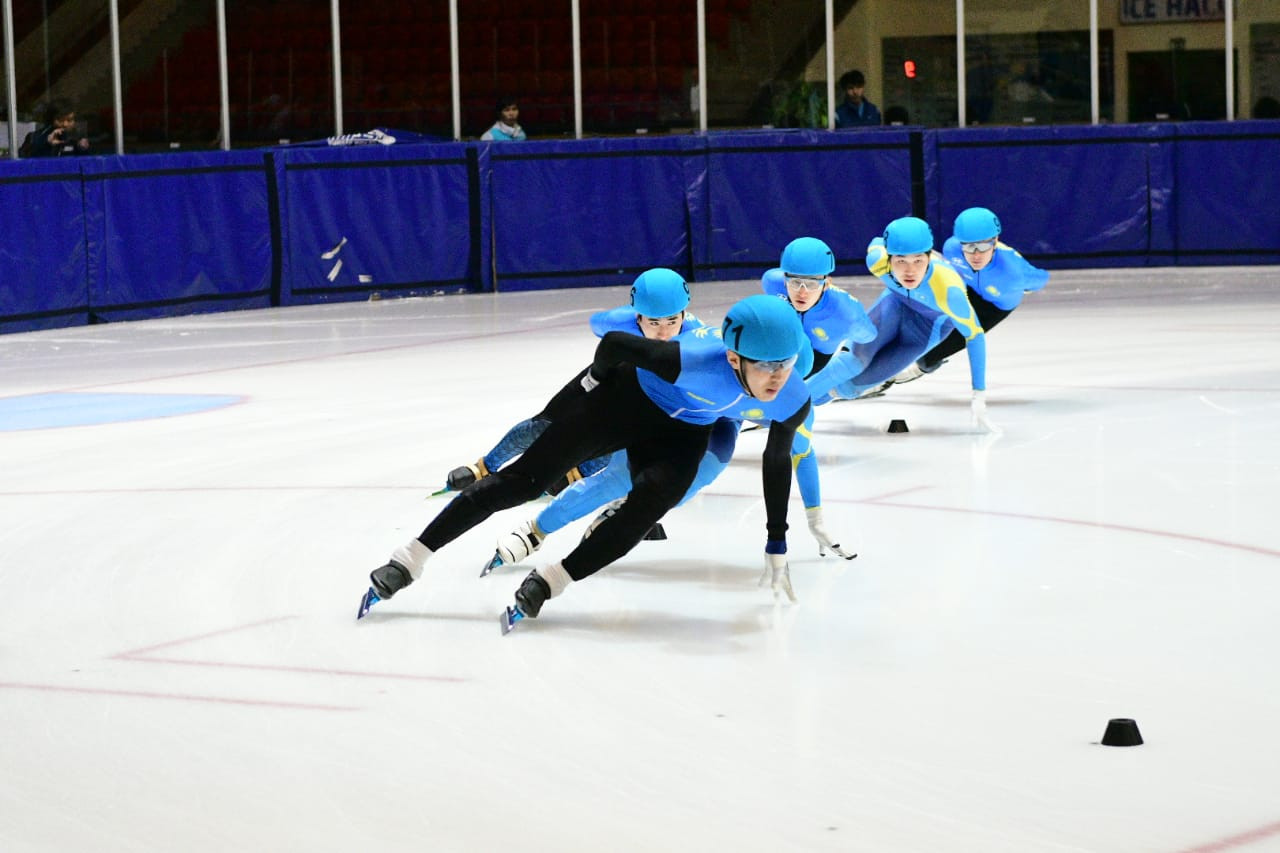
[925,124,1174,268]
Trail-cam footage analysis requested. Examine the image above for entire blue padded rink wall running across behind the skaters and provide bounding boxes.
[0,120,1280,332]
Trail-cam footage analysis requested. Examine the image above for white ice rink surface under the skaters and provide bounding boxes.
[0,268,1280,853]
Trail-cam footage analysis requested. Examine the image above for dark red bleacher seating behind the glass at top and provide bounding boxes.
[125,0,750,140]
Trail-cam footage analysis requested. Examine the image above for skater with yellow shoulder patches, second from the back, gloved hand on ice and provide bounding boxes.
[808,216,996,432]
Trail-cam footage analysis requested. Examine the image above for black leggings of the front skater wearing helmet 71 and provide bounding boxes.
[417,368,712,580]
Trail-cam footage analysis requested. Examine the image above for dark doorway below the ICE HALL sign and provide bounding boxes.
[1129,47,1226,122]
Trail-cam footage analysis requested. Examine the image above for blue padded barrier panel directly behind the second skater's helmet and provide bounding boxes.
[479,136,703,291]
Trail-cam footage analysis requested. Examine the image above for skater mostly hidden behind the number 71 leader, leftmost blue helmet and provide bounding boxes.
[444,266,703,494]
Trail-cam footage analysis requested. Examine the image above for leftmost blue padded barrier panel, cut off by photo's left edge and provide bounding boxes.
[0,158,88,332]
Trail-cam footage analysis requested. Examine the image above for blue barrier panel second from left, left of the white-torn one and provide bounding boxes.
[82,151,271,321]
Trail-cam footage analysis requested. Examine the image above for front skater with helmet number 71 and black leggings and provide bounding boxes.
[357,295,813,630]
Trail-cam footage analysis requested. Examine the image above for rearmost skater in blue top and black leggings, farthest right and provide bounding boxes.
[888,207,1048,384]
